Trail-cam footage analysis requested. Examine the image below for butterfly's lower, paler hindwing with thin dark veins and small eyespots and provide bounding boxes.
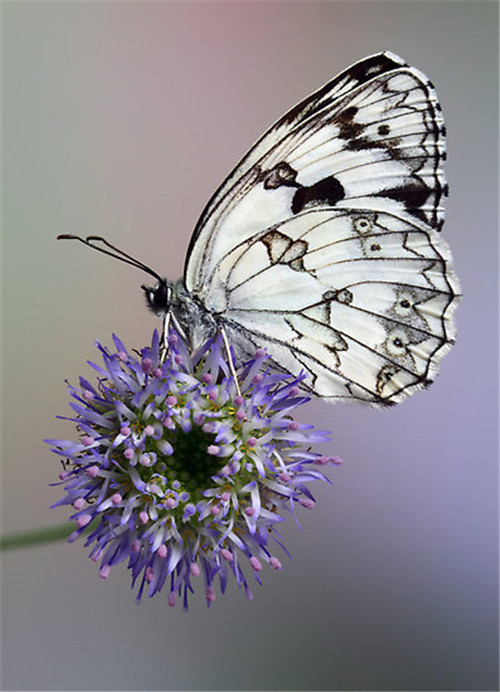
[201,208,454,403]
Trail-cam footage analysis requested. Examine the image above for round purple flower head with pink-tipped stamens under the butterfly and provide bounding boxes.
[46,331,339,609]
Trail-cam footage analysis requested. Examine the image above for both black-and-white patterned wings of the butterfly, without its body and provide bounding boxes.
[184,52,459,404]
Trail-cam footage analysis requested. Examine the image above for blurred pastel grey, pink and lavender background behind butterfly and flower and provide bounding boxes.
[2,2,498,690]
